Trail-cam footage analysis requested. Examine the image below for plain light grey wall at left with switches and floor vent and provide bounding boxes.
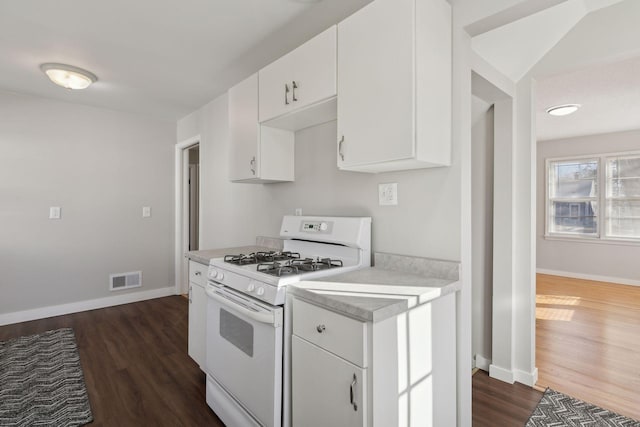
[0,92,175,314]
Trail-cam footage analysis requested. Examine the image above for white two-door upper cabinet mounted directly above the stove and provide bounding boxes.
[258,25,336,130]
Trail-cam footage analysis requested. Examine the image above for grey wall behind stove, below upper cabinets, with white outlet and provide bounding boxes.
[252,121,460,261]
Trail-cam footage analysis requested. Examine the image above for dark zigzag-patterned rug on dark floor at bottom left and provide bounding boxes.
[0,328,93,426]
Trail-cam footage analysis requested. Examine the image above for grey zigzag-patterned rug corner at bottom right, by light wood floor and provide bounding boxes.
[525,388,640,427]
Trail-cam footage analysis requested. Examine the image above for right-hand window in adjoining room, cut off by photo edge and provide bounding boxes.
[606,155,640,239]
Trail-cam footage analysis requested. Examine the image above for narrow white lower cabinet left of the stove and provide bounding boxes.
[188,261,207,371]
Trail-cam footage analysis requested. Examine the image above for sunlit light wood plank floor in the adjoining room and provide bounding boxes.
[536,274,640,420]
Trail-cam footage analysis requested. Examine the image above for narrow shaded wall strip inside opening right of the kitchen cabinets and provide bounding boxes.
[471,96,494,370]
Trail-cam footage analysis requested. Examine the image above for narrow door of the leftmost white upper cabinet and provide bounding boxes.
[228,74,260,181]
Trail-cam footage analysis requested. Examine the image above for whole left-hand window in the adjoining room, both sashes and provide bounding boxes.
[547,159,599,236]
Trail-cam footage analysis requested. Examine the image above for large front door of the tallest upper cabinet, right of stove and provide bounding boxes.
[338,0,415,167]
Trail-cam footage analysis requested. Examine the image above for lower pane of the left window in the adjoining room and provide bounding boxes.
[549,201,598,235]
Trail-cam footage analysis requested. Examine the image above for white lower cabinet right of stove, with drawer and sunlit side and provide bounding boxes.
[287,291,457,427]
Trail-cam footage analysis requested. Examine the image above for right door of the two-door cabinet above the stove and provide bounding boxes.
[291,25,337,113]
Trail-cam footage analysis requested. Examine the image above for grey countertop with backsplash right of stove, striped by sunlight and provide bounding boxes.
[287,254,461,323]
